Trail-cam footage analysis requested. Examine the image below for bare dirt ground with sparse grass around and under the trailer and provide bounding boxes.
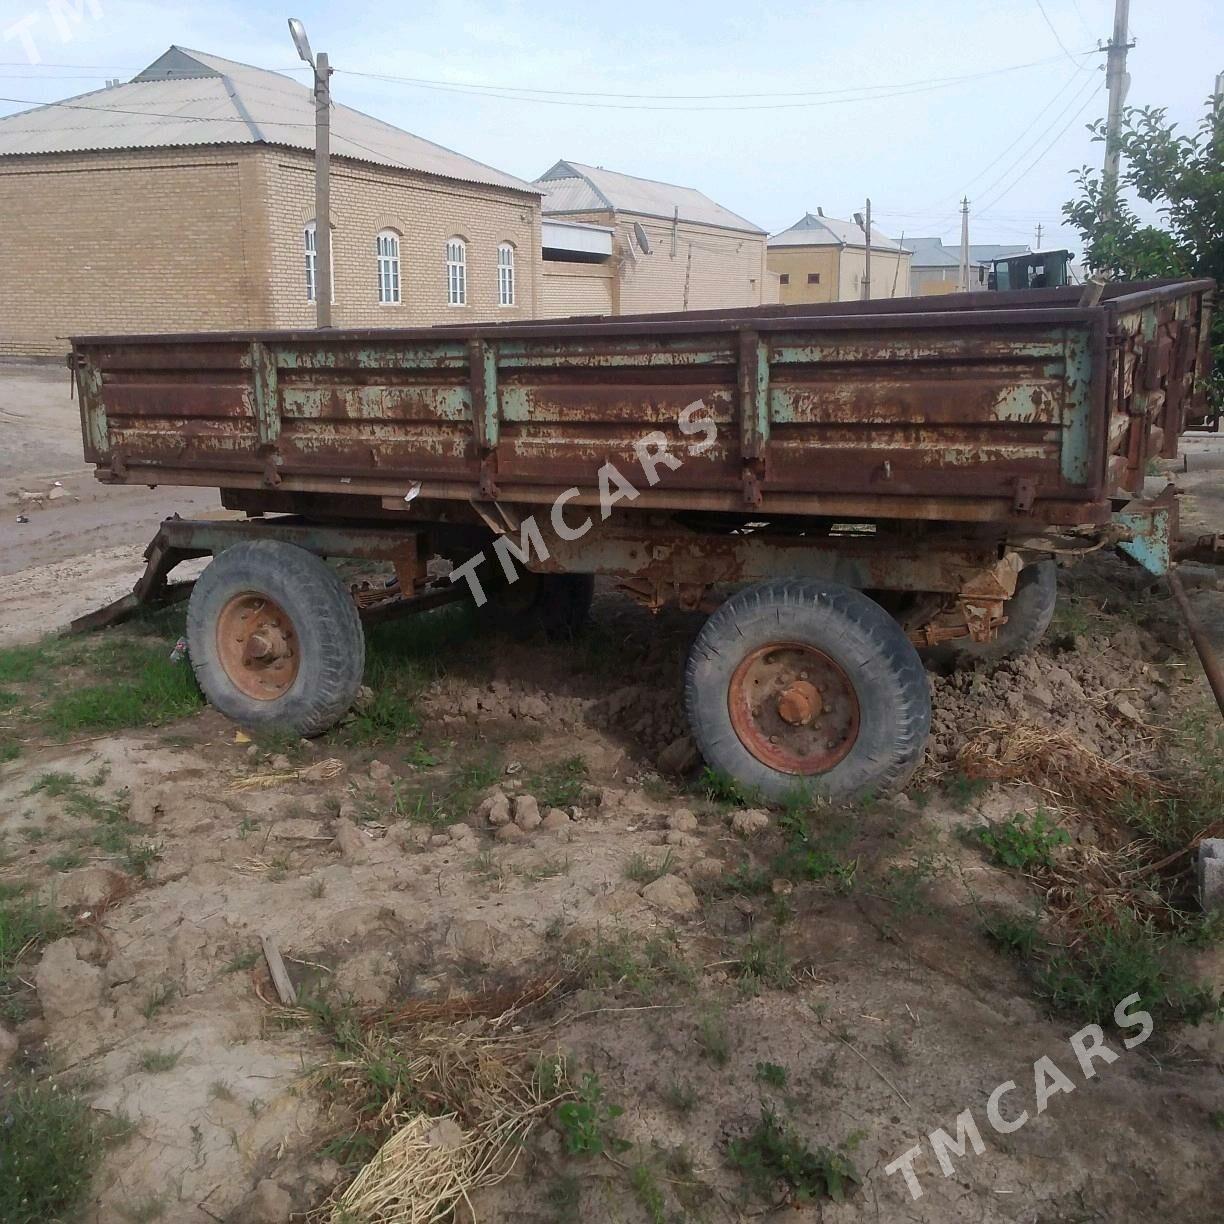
[0,357,1224,1224]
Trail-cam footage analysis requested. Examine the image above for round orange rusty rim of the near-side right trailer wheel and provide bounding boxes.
[727,641,859,775]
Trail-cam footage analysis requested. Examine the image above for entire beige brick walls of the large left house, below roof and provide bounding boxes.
[0,146,541,356]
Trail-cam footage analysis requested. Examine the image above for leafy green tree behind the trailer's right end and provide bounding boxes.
[1062,98,1224,411]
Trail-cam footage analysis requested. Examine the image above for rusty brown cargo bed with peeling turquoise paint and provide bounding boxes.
[70,280,1213,526]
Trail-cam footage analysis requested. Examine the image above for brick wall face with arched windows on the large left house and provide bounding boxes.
[261,149,541,327]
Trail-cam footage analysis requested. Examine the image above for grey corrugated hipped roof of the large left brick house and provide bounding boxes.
[0,47,539,195]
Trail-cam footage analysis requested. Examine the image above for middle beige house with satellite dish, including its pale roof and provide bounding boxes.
[534,162,771,315]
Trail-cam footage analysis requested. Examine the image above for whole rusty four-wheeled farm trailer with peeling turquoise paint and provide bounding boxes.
[69,280,1214,799]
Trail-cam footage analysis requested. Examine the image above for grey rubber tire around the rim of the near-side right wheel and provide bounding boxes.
[684,579,930,799]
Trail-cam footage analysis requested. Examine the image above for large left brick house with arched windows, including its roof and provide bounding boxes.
[0,48,541,356]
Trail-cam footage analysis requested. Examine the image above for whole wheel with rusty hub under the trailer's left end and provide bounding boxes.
[187,540,366,736]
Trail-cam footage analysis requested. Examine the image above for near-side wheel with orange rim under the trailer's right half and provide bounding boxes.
[684,579,930,800]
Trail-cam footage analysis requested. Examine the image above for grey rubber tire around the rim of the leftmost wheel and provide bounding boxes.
[187,540,366,736]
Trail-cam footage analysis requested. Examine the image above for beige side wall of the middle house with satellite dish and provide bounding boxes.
[545,213,767,315]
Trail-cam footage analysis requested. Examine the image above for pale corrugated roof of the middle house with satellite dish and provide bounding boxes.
[535,162,765,234]
